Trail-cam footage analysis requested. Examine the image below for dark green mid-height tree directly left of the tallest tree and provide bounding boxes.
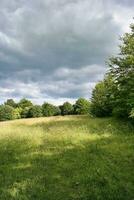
[91,75,114,117]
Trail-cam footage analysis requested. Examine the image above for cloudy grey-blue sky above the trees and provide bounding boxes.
[0,0,134,105]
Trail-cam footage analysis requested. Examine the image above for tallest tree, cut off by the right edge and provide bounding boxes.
[109,24,134,117]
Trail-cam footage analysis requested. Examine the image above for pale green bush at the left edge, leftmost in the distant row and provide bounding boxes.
[0,105,14,121]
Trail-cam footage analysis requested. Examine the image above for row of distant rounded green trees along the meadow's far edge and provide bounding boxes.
[0,98,91,121]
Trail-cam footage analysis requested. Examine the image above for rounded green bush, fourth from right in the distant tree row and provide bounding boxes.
[28,105,42,117]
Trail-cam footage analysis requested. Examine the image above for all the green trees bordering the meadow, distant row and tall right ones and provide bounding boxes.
[0,24,134,121]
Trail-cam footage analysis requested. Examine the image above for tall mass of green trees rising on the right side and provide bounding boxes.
[91,22,134,118]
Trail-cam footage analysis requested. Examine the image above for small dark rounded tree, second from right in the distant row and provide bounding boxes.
[60,102,74,115]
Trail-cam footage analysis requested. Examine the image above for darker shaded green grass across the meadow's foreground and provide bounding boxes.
[0,130,134,200]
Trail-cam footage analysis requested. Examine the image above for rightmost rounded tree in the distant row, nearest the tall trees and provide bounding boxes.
[74,98,91,115]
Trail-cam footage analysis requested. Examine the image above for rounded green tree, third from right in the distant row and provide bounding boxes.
[42,103,56,117]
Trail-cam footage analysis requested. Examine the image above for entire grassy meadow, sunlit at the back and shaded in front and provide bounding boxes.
[0,116,134,200]
